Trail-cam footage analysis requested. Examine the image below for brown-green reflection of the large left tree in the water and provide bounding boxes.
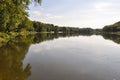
[0,37,31,80]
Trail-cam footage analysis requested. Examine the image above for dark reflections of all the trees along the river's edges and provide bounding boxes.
[0,34,120,80]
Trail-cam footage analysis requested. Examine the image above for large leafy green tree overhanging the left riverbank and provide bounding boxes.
[0,0,41,32]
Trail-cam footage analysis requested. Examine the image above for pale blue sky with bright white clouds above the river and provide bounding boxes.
[29,0,120,28]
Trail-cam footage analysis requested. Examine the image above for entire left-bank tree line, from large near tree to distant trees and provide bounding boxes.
[0,0,100,33]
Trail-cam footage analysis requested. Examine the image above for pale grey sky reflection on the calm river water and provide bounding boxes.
[24,34,120,80]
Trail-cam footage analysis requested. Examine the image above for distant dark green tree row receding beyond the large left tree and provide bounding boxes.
[33,21,95,34]
